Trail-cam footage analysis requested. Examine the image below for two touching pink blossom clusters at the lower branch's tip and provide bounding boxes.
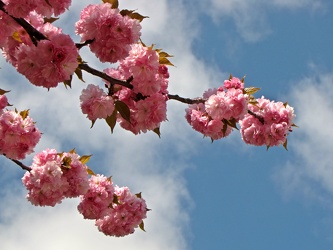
[78,175,147,237]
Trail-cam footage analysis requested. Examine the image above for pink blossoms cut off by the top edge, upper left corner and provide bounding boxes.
[3,0,72,18]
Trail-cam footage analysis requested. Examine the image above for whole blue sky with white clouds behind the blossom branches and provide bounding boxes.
[0,0,333,250]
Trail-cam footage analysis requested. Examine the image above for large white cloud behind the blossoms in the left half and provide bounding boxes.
[0,0,220,250]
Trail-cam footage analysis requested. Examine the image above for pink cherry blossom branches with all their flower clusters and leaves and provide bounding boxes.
[0,0,295,237]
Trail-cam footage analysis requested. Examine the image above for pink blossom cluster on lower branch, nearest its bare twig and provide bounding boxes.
[22,149,89,206]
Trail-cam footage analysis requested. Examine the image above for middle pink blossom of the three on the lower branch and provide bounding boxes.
[78,175,114,219]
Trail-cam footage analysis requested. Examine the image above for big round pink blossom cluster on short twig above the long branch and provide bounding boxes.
[75,3,141,63]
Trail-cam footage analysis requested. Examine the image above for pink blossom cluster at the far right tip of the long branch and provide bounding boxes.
[239,97,295,147]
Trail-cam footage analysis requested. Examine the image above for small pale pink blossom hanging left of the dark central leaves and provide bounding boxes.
[80,84,114,121]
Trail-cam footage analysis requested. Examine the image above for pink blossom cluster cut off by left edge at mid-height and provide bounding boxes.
[0,106,41,160]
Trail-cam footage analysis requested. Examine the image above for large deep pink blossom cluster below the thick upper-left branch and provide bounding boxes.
[14,23,78,88]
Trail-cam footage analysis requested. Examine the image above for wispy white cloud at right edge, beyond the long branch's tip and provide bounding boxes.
[275,71,333,206]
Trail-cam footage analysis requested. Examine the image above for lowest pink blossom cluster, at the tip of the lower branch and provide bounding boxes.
[96,186,148,237]
